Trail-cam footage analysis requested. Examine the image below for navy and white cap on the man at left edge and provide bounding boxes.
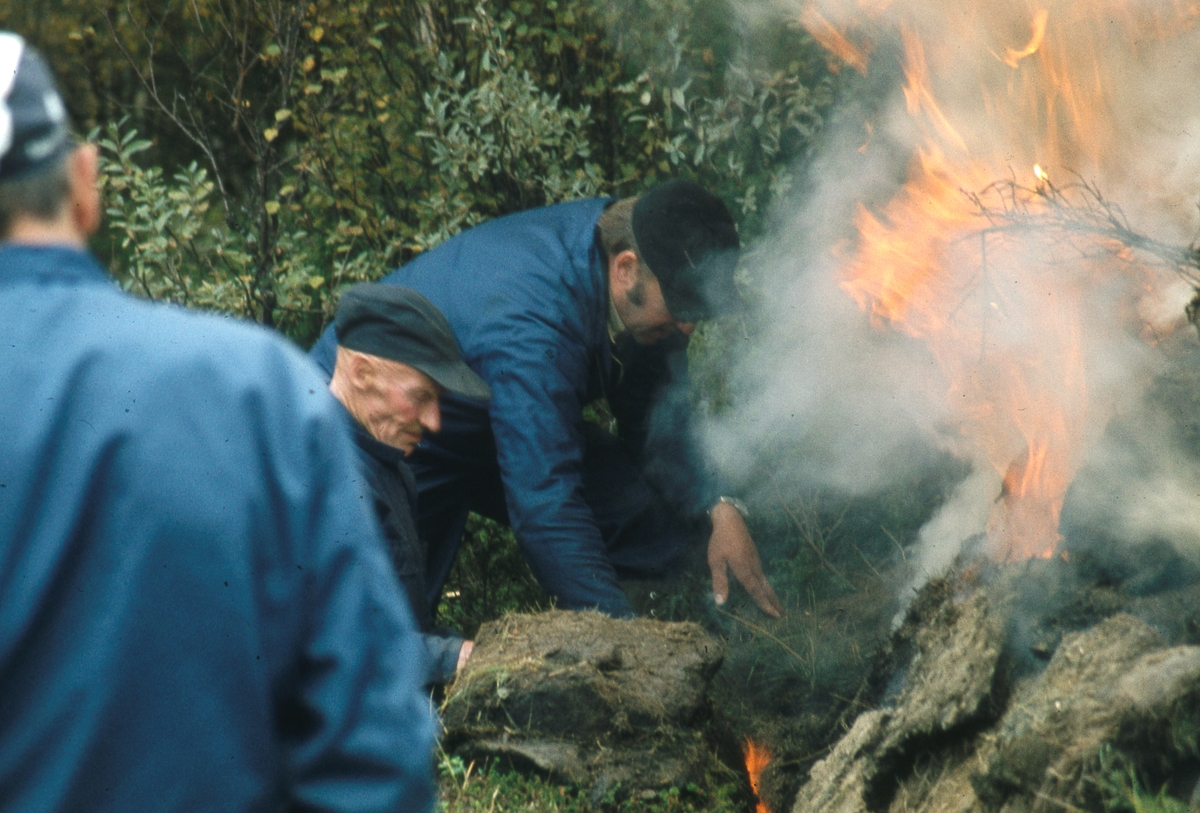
[0,31,71,181]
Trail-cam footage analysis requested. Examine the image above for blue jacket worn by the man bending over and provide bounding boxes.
[312,198,703,615]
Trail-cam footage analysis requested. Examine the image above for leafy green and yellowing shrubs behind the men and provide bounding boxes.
[52,0,833,343]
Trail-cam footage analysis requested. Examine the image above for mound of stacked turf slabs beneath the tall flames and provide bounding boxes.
[792,573,1200,813]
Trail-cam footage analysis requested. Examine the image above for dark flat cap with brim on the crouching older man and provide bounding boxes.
[334,282,492,399]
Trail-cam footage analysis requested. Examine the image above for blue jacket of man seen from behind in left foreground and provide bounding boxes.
[0,246,433,813]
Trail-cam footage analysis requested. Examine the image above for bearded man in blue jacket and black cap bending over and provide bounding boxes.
[312,181,781,616]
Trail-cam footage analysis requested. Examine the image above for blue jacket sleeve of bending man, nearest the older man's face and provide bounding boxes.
[481,315,634,616]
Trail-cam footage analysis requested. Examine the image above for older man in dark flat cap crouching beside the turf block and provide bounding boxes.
[329,283,491,683]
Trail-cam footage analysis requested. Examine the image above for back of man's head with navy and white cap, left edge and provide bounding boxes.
[0,31,72,237]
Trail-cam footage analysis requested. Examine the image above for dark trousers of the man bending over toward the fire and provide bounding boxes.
[408,407,706,607]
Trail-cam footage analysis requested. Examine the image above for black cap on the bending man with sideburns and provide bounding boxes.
[631,180,742,321]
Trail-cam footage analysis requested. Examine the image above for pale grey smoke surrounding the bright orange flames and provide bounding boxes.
[706,0,1200,579]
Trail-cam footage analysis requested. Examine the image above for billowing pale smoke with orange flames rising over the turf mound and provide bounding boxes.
[706,0,1200,579]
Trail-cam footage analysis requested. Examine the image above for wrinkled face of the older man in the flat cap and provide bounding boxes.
[355,356,443,456]
